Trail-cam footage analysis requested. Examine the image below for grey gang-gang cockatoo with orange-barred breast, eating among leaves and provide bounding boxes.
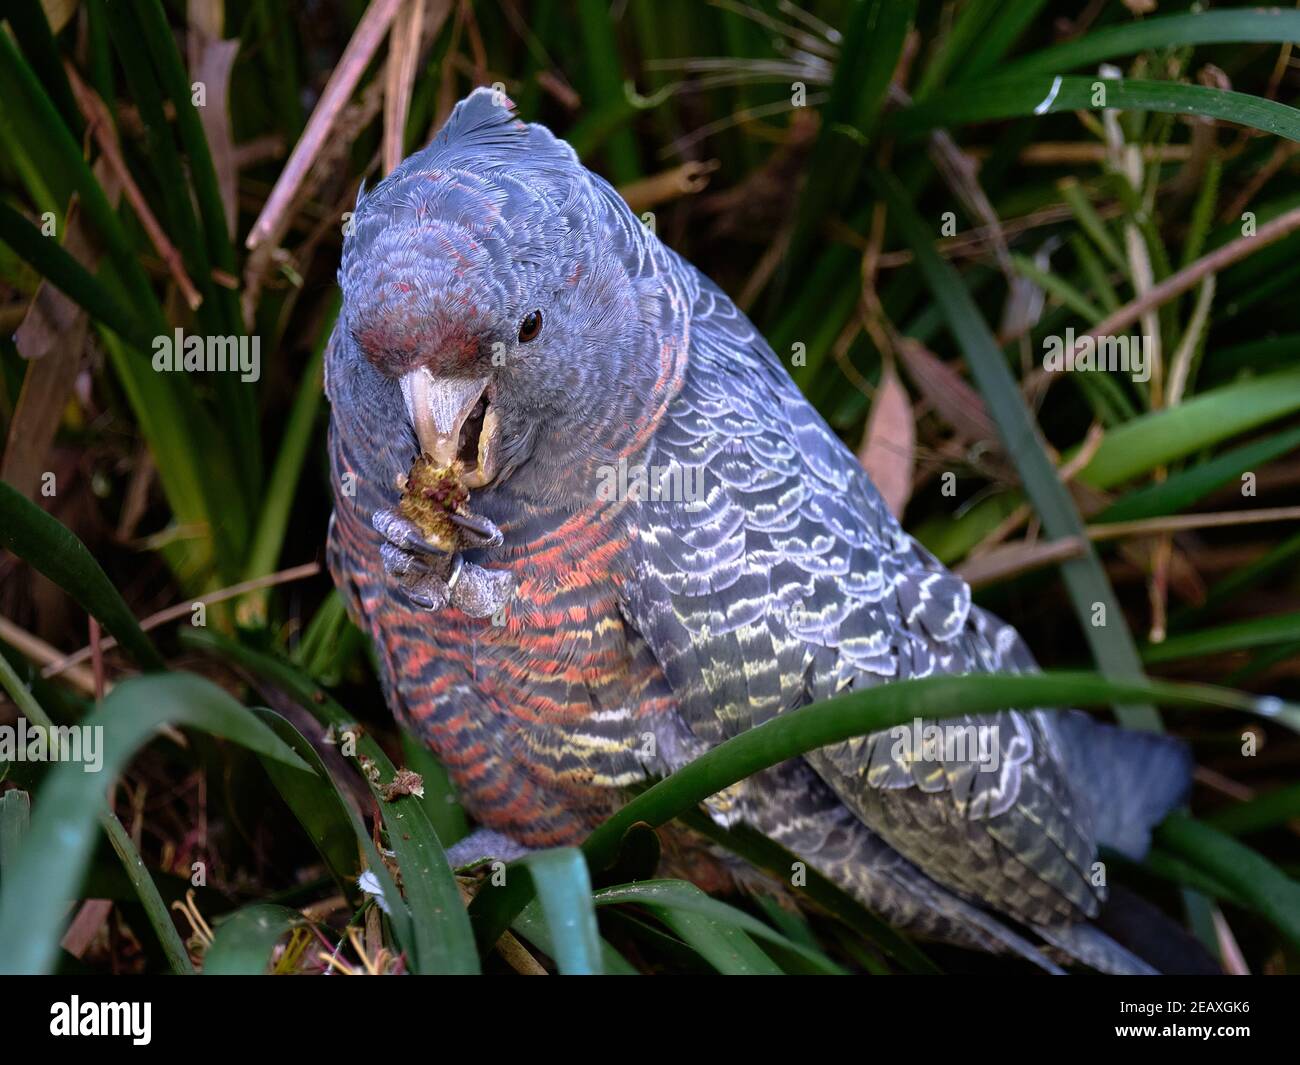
[326,90,1190,971]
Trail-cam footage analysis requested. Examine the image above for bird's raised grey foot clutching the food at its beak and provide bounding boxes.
[372,508,515,618]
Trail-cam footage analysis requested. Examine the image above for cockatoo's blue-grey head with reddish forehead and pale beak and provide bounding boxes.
[332,88,671,499]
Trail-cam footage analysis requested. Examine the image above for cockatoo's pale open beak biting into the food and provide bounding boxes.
[400,367,499,488]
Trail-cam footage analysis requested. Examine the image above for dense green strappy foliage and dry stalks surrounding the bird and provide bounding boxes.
[0,0,1300,973]
